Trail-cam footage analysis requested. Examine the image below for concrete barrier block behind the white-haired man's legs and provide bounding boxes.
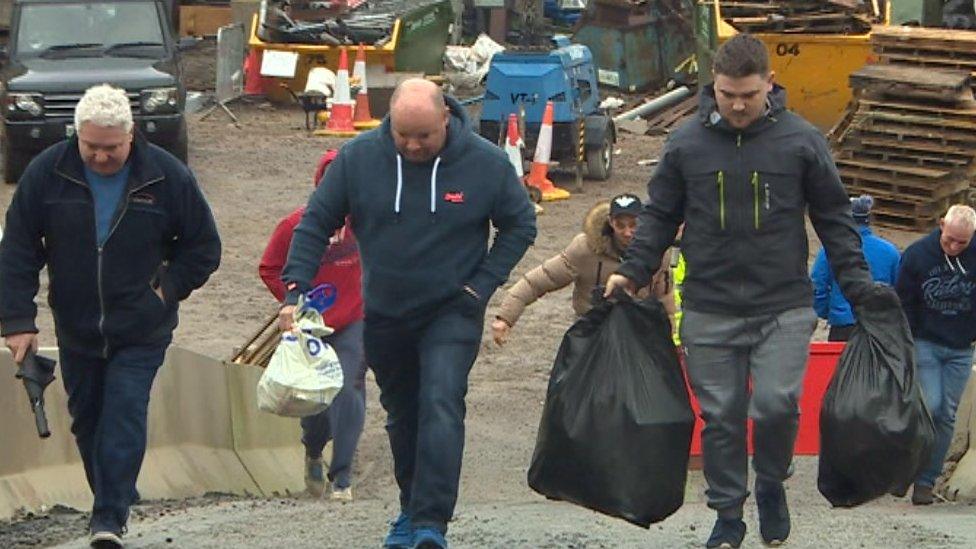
[0,347,266,518]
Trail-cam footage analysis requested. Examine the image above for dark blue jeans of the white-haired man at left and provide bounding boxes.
[59,343,169,531]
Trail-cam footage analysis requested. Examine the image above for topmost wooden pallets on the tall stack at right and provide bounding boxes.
[871,27,976,88]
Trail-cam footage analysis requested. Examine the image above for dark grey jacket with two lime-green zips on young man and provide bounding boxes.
[617,86,871,316]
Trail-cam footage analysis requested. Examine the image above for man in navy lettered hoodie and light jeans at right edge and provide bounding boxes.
[895,204,976,505]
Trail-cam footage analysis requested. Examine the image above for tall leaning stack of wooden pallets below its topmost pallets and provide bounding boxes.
[830,64,976,230]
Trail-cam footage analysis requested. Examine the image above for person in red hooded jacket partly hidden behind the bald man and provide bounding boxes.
[258,149,366,501]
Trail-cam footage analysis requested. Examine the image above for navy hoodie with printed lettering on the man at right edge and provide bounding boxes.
[895,229,976,349]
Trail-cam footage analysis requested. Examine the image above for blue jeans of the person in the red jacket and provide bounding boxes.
[301,320,366,488]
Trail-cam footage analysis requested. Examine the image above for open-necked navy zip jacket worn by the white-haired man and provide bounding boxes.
[0,136,220,357]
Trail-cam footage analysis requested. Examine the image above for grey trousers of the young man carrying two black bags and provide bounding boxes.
[681,307,817,518]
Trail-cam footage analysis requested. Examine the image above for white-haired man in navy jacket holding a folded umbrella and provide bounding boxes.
[0,85,220,547]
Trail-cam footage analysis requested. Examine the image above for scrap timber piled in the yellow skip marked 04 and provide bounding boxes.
[719,0,882,34]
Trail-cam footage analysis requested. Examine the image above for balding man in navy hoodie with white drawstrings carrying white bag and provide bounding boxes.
[281,79,536,548]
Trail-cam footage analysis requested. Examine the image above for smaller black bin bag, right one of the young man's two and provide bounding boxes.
[817,286,935,507]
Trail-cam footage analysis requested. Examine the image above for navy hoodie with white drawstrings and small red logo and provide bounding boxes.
[282,97,536,318]
